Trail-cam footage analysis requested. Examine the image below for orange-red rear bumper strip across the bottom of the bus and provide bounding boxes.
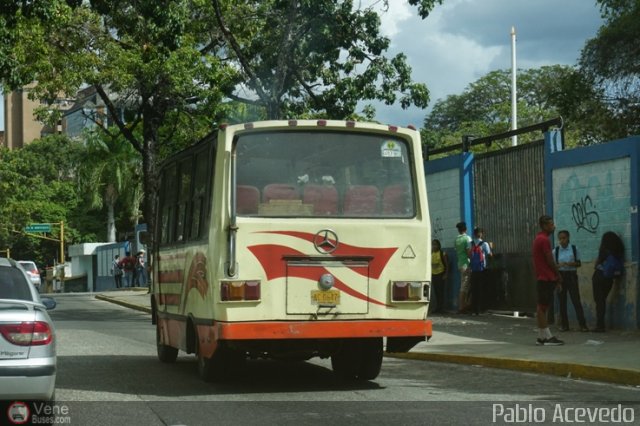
[216,320,432,340]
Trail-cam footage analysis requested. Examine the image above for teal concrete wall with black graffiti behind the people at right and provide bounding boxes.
[546,137,640,329]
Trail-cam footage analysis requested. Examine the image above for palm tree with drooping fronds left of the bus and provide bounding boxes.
[77,131,142,242]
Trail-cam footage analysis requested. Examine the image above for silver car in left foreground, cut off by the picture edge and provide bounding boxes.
[0,258,56,401]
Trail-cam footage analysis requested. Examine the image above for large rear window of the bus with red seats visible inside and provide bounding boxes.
[235,131,416,218]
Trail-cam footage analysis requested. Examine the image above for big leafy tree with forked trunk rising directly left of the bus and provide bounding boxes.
[5,0,235,248]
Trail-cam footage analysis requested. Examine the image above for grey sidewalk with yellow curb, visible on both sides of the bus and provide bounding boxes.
[96,288,640,386]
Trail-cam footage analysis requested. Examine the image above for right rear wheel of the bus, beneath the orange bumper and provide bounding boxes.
[331,338,382,380]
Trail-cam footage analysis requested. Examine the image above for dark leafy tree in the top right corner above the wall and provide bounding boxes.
[576,0,640,139]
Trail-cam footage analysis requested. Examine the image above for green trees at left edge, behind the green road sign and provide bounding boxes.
[0,135,100,263]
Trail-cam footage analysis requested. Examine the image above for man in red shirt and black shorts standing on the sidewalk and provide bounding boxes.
[532,215,564,346]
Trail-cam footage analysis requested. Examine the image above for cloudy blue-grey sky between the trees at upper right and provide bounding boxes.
[0,0,602,129]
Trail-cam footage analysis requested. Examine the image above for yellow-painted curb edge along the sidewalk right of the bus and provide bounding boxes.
[385,352,640,386]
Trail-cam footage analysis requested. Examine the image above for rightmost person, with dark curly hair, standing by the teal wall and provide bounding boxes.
[591,231,624,332]
